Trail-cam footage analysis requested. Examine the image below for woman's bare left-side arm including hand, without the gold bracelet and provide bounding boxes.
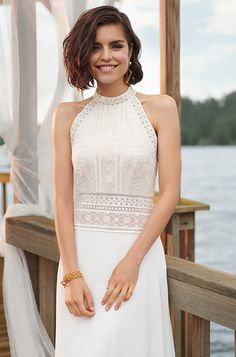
[52,103,95,317]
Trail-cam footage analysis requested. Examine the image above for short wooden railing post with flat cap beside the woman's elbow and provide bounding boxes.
[154,192,210,357]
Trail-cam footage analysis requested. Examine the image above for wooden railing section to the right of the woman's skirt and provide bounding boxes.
[166,256,236,357]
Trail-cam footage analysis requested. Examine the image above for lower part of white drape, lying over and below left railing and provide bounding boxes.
[0,203,54,357]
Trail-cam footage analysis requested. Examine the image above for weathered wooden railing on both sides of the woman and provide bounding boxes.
[3,216,236,357]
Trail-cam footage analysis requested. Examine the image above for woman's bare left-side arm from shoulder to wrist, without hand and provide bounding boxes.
[52,103,78,274]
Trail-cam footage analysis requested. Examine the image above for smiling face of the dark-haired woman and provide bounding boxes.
[89,24,131,84]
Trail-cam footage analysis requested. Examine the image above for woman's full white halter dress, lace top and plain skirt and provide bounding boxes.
[55,86,175,357]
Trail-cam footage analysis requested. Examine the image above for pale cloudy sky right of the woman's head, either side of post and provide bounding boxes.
[121,0,236,100]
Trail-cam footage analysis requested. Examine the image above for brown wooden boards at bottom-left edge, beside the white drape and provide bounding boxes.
[0,257,10,357]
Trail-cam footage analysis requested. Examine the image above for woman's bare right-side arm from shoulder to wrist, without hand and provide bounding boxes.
[127,95,181,264]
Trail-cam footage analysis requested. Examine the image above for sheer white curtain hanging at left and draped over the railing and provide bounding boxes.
[0,0,118,357]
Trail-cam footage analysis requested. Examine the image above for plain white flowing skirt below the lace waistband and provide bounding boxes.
[55,228,175,357]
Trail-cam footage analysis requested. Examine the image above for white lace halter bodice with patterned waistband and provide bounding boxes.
[70,86,157,232]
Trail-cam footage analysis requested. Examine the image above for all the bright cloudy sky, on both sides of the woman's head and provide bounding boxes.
[0,0,236,121]
